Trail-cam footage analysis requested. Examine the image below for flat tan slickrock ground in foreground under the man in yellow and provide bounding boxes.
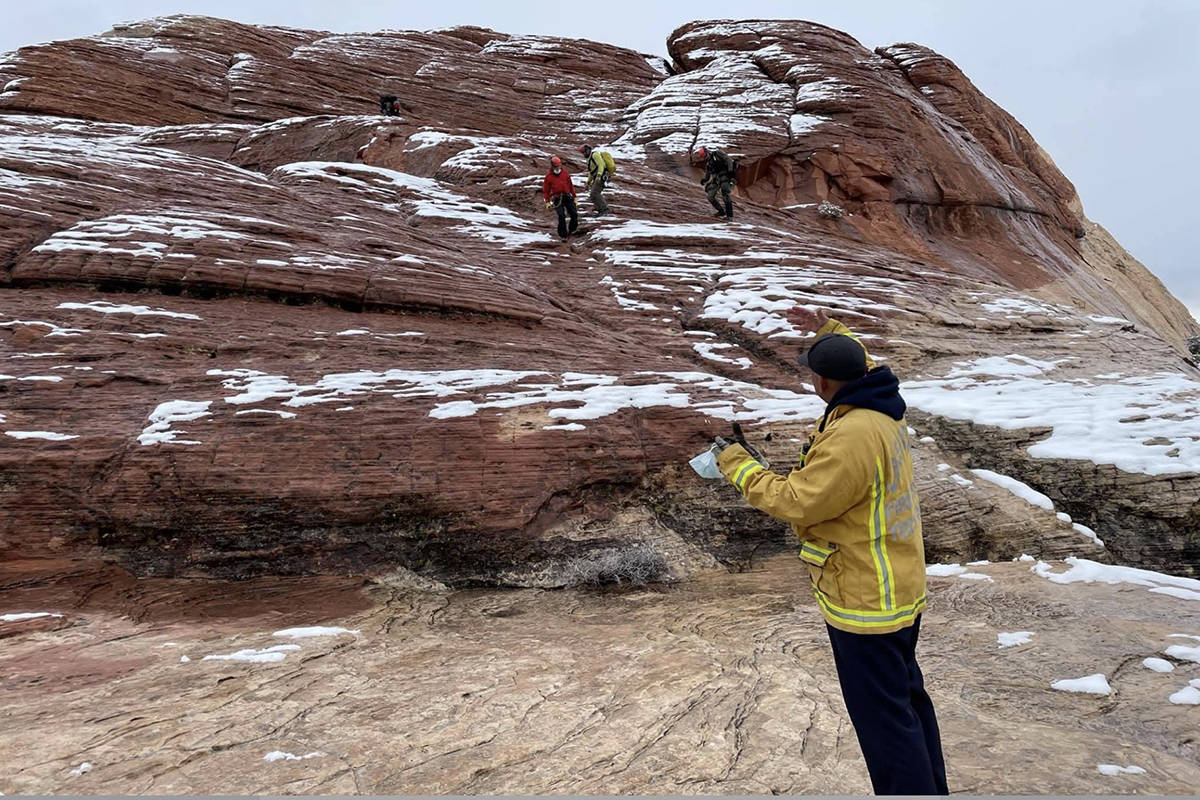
[0,557,1200,795]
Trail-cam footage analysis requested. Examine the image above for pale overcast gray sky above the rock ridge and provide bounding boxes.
[0,0,1200,318]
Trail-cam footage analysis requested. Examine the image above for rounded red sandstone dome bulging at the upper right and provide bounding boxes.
[657,22,1171,319]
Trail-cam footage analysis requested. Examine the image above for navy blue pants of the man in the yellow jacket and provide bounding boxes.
[826,616,948,794]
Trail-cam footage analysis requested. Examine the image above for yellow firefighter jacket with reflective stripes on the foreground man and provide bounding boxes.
[718,323,925,633]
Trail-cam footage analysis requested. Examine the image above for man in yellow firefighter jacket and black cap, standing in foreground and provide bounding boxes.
[718,312,947,794]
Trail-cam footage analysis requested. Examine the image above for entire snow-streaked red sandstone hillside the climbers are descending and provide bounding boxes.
[0,17,1200,585]
